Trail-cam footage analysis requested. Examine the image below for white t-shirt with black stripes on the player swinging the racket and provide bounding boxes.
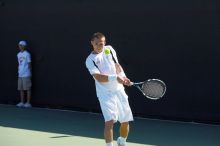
[86,46,124,97]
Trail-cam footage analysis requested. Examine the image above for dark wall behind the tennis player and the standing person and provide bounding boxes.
[0,0,220,122]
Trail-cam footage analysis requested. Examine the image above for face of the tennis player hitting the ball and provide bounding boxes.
[91,37,105,54]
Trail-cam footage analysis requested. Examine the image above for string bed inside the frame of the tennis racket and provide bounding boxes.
[142,82,164,98]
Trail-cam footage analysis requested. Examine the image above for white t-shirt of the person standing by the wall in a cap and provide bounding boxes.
[17,50,31,77]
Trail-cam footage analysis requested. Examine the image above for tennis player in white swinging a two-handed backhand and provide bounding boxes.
[86,32,133,146]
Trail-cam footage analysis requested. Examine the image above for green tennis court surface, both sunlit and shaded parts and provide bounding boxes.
[0,105,220,146]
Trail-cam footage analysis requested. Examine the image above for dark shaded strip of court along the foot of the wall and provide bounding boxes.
[0,105,220,146]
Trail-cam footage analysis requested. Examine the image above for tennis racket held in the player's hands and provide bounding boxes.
[131,79,166,100]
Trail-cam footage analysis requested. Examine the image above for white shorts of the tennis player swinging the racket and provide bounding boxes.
[99,89,133,123]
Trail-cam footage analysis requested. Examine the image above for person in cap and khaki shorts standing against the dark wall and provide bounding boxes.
[17,41,32,108]
